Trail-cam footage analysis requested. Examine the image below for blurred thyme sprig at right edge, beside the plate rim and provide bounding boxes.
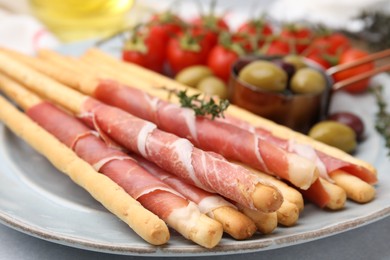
[371,86,390,156]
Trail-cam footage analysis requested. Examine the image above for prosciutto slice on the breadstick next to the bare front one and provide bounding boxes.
[26,102,192,220]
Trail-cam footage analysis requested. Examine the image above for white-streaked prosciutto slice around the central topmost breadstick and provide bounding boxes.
[83,98,277,209]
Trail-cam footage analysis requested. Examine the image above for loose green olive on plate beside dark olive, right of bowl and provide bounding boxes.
[308,121,357,153]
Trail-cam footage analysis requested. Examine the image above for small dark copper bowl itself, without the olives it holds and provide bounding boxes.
[228,56,333,133]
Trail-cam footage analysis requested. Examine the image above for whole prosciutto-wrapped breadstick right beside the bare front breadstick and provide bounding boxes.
[0,74,222,248]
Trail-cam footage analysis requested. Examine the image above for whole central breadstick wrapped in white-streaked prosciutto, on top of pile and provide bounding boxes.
[0,49,283,212]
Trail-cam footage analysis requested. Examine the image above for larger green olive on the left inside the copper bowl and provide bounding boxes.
[238,60,288,92]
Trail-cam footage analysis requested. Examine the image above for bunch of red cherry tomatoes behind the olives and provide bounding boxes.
[122,11,374,93]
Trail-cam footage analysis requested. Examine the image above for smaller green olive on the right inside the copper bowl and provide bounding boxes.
[290,67,326,94]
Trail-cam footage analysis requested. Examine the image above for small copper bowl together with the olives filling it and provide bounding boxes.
[228,55,333,133]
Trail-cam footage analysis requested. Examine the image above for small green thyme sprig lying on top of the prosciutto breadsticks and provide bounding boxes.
[176,90,230,120]
